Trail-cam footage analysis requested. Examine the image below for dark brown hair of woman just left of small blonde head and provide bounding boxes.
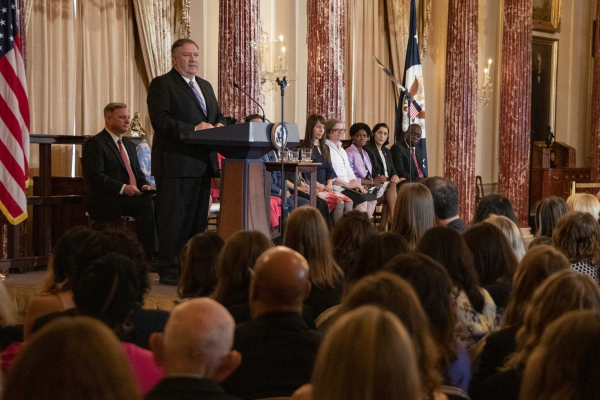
[463,222,518,286]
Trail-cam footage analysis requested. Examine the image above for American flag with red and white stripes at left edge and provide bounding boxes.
[0,0,29,225]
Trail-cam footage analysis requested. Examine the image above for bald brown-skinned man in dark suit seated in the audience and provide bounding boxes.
[223,246,322,400]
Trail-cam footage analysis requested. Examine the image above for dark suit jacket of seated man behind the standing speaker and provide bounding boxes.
[81,129,148,219]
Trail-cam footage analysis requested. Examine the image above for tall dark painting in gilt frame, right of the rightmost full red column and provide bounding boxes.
[531,36,558,141]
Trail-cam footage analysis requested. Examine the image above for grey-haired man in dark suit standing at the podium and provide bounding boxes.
[148,39,225,285]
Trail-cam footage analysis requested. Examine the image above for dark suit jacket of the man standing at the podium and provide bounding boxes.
[148,68,225,178]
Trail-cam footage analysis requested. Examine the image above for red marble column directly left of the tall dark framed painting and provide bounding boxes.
[498,0,533,227]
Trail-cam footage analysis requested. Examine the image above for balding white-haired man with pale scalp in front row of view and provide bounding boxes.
[145,298,242,400]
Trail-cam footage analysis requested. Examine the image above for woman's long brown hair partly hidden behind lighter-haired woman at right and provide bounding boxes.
[502,245,569,327]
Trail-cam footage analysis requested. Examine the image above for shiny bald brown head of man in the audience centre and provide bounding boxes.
[250,246,311,317]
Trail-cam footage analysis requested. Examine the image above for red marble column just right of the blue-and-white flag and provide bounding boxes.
[444,0,479,221]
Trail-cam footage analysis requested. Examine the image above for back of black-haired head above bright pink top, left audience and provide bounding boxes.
[73,253,140,333]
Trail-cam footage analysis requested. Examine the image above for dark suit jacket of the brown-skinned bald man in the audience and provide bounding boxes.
[223,313,323,400]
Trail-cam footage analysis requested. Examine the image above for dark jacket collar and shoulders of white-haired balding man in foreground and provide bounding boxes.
[144,376,239,400]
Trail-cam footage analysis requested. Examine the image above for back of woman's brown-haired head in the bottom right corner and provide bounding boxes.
[520,310,600,400]
